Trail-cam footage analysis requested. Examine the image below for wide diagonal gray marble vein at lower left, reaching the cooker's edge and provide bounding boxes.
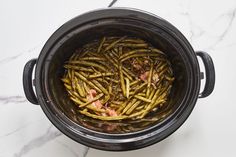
[14,126,62,157]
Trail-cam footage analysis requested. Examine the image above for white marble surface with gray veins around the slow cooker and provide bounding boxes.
[0,0,236,157]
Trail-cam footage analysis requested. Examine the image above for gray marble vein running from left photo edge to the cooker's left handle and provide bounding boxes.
[0,96,27,105]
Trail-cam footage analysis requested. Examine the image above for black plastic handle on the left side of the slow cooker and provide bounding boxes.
[23,59,38,105]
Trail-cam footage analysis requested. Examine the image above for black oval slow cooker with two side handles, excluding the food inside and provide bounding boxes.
[23,8,215,151]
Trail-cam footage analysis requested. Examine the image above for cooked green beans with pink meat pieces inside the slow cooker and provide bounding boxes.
[61,36,174,120]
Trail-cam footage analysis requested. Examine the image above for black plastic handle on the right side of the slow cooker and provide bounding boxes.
[196,51,215,98]
